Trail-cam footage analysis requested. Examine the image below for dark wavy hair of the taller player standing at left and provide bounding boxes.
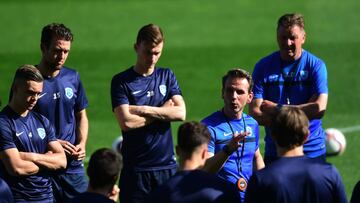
[41,23,74,47]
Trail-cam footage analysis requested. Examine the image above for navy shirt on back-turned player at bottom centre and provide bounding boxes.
[145,170,240,203]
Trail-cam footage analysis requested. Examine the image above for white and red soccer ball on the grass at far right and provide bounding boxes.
[325,128,346,156]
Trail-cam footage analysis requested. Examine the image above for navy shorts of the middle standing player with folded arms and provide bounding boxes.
[119,168,177,203]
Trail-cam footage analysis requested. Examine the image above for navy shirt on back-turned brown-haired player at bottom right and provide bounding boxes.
[246,156,348,203]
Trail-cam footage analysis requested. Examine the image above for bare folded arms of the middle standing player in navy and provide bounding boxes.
[114,95,186,131]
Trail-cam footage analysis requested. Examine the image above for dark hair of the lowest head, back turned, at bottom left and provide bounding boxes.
[87,148,122,189]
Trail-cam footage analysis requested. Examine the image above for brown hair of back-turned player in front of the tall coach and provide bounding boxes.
[270,106,309,149]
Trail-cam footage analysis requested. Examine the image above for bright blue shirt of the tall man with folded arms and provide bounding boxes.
[252,50,328,158]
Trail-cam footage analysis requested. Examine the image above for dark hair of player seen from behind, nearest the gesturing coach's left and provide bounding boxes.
[177,121,211,156]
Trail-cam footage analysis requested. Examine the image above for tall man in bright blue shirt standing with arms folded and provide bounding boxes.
[249,13,328,164]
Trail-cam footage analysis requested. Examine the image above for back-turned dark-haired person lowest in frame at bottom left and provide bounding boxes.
[68,148,122,203]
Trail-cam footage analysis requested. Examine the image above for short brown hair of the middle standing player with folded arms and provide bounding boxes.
[136,24,165,45]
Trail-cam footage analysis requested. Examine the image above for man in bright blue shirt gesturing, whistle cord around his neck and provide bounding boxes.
[202,68,264,202]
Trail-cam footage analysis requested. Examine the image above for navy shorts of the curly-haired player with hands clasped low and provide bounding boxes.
[52,172,89,203]
